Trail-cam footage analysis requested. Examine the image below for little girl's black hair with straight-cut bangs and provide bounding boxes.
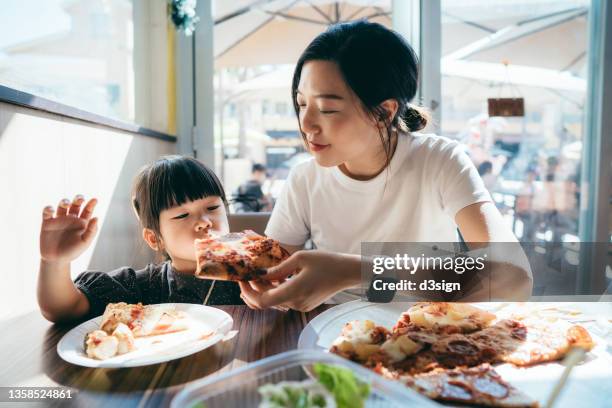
[132,155,227,237]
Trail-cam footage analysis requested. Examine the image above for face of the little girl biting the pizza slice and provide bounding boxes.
[159,196,229,272]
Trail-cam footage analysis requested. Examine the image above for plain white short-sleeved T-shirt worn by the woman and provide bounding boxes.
[266,133,491,254]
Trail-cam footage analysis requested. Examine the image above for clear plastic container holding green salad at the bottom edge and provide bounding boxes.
[171,350,440,408]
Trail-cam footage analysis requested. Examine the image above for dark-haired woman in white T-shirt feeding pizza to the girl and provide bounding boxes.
[241,21,531,310]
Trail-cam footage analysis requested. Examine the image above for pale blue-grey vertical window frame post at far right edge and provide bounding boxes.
[576,0,612,294]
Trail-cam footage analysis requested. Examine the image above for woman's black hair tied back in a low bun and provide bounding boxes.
[291,20,427,164]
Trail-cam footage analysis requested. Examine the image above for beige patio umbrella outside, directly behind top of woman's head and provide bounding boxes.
[213,0,391,68]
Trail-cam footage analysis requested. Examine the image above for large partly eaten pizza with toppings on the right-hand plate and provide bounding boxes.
[330,302,594,407]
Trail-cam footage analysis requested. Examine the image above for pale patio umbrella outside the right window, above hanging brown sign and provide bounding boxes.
[441,1,589,118]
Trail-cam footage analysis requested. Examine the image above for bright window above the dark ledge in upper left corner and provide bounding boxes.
[0,0,175,133]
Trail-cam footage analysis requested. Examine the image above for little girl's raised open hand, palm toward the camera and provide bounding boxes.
[40,195,98,262]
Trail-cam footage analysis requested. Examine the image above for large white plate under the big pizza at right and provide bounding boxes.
[298,300,612,408]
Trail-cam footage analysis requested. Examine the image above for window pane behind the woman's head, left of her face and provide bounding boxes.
[213,0,392,210]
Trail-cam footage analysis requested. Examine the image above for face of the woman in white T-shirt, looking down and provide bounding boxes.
[296,60,385,176]
